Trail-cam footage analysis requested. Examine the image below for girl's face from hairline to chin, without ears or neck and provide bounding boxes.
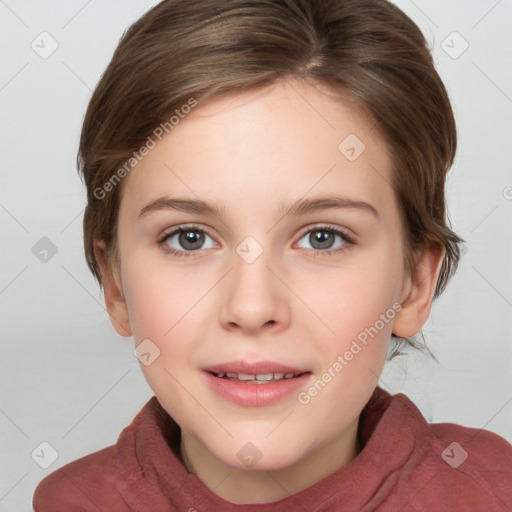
[111,80,412,484]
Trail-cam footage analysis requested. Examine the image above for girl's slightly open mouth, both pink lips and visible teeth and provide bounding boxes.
[203,361,312,407]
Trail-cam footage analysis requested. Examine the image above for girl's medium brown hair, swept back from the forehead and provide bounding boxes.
[78,0,461,354]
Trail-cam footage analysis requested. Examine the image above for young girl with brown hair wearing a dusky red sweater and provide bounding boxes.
[33,0,512,512]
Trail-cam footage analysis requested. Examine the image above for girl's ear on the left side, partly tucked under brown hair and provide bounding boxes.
[94,240,132,336]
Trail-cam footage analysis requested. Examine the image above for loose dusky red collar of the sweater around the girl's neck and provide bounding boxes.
[117,387,429,512]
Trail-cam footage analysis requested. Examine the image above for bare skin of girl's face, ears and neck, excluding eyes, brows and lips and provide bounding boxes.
[96,79,442,503]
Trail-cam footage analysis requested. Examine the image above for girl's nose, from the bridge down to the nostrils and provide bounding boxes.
[219,248,290,335]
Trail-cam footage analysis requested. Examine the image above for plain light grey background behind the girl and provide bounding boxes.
[0,0,512,512]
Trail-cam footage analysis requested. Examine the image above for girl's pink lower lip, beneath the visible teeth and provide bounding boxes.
[204,372,311,407]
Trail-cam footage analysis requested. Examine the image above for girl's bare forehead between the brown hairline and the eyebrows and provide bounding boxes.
[118,80,392,217]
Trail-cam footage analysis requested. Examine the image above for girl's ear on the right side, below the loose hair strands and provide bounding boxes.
[393,245,444,338]
